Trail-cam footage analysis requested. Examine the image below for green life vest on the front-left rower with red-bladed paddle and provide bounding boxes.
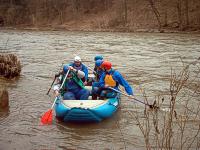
[61,72,85,96]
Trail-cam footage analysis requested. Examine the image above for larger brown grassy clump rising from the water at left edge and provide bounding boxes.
[0,53,21,78]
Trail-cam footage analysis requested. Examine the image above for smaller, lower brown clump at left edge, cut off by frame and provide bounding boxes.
[0,87,9,109]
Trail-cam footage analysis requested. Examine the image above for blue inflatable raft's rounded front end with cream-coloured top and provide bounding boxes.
[55,94,120,122]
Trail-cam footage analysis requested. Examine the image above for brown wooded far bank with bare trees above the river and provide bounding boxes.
[0,0,200,30]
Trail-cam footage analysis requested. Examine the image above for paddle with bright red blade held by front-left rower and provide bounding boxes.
[40,69,70,125]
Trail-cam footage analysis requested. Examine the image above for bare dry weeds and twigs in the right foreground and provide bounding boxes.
[129,59,200,150]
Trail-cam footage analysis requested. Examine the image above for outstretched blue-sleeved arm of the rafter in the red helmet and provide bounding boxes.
[114,72,133,95]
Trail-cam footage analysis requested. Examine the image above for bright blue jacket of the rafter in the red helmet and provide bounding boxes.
[99,69,133,95]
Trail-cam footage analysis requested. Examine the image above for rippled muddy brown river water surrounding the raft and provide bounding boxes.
[0,30,200,150]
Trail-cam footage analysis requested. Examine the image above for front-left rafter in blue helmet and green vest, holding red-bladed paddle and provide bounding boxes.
[54,65,90,100]
